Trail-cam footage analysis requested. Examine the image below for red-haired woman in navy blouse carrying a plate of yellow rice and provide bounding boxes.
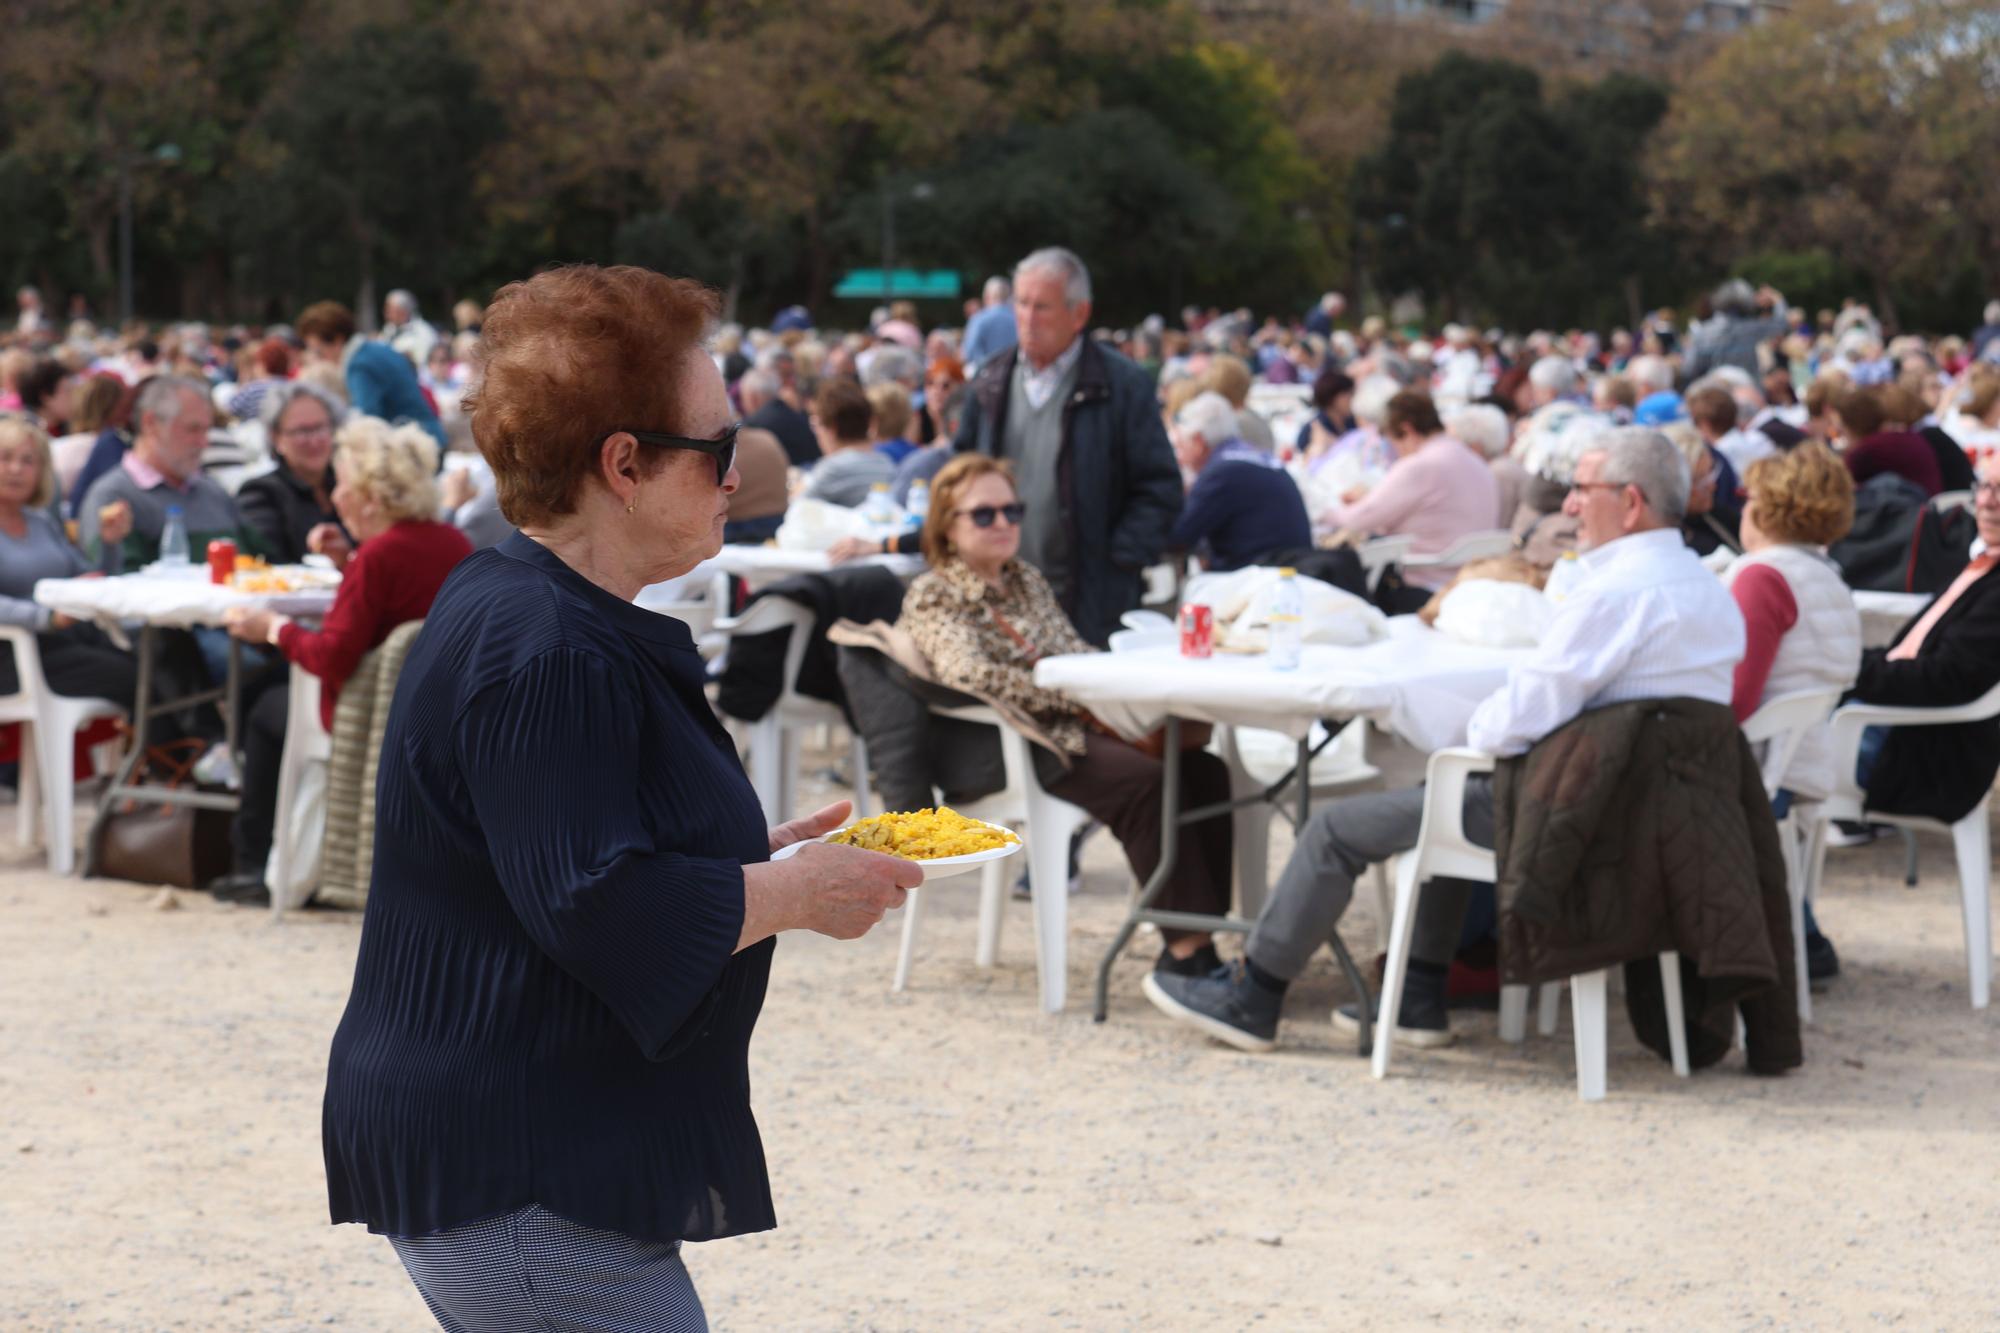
[324,266,922,1329]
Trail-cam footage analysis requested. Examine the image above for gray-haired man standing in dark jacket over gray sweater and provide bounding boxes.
[954,248,1182,646]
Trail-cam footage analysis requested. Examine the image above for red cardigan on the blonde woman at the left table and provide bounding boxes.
[278,518,472,731]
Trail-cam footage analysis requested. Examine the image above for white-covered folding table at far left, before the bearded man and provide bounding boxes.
[34,564,336,879]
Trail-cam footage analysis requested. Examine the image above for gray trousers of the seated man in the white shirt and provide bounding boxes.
[1248,777,1494,981]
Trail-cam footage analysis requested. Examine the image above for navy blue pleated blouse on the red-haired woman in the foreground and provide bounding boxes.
[322,534,774,1241]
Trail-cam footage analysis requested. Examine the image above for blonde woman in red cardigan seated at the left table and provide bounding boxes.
[210,416,472,903]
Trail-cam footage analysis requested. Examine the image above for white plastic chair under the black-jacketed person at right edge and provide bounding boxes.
[1806,687,2000,1009]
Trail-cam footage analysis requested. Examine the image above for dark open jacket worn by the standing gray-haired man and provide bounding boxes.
[952,338,1182,648]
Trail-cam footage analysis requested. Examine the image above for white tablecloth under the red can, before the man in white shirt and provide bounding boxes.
[1034,616,1530,751]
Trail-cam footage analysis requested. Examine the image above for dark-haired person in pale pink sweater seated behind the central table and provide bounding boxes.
[1324,388,1500,610]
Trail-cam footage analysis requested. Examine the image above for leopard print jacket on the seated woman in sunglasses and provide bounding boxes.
[896,558,1096,755]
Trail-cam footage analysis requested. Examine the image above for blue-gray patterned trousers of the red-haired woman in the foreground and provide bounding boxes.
[388,1203,708,1333]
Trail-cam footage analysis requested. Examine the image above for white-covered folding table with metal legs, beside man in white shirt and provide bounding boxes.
[1034,616,1530,1020]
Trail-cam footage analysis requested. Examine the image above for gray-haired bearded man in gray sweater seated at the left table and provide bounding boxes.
[76,374,256,574]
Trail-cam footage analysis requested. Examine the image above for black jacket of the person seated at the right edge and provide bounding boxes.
[1850,552,2000,823]
